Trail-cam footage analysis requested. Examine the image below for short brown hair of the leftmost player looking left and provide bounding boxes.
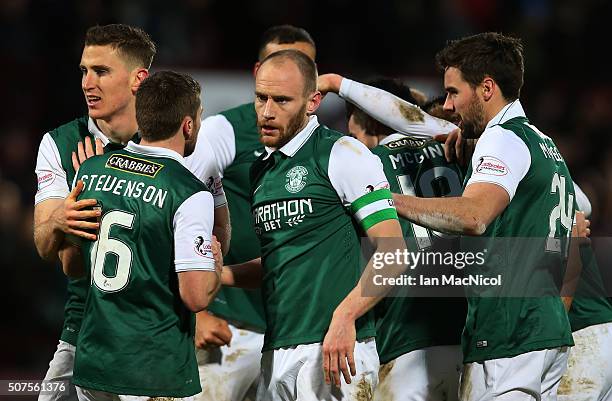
[85,24,157,69]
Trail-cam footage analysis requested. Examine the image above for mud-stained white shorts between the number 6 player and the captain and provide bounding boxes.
[194,324,264,401]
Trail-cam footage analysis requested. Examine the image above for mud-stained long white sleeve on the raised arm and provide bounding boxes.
[339,78,457,136]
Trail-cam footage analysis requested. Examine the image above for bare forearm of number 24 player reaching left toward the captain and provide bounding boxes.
[393,194,487,235]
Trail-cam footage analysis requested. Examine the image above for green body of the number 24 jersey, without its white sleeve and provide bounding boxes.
[462,117,574,363]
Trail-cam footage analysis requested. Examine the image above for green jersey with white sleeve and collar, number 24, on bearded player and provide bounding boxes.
[462,100,574,363]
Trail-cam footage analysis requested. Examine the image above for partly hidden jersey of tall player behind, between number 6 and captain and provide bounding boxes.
[188,103,266,332]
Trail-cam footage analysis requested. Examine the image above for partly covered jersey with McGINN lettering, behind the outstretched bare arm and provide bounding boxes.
[372,134,467,363]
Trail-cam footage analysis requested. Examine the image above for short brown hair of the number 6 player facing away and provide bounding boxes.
[136,71,201,142]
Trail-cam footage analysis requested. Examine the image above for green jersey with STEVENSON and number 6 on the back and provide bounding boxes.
[74,143,215,397]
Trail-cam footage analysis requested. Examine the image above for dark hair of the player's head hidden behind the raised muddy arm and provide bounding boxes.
[346,77,417,136]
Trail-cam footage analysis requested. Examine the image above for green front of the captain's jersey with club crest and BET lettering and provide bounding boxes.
[251,126,375,351]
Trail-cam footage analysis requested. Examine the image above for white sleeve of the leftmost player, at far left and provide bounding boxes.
[34,133,70,204]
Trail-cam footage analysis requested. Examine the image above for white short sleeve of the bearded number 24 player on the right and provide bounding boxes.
[466,126,531,201]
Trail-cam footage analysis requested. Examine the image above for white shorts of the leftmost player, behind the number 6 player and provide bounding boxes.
[38,340,77,401]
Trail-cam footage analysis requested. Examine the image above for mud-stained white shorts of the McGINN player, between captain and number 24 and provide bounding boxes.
[374,345,463,401]
